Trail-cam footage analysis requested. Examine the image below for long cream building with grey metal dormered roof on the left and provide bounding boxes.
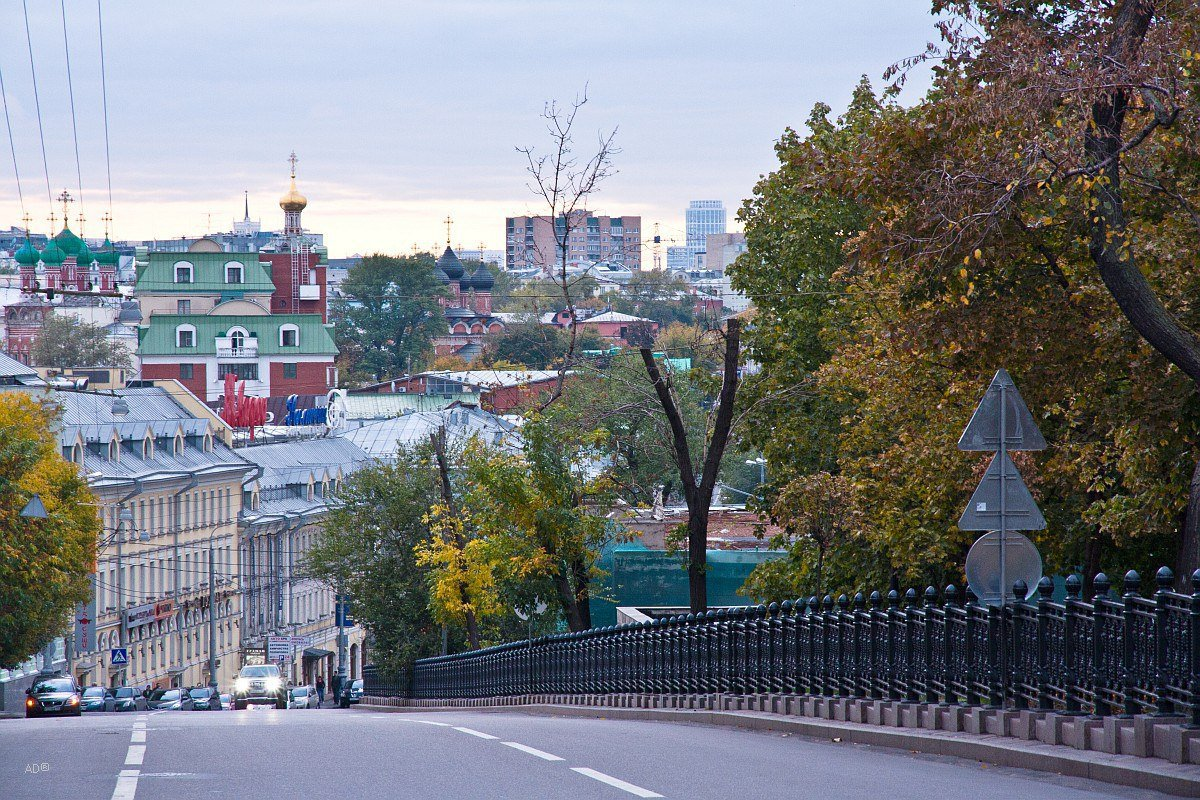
[54,385,254,686]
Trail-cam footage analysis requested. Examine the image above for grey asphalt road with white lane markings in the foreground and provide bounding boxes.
[0,708,1166,800]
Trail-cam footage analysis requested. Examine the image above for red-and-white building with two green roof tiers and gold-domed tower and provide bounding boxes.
[137,165,337,401]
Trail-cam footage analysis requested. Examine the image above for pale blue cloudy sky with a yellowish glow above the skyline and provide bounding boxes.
[0,0,936,256]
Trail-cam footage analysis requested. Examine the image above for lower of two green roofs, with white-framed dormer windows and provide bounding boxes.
[138,314,337,356]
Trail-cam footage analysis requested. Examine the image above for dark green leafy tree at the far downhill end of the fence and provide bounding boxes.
[304,447,442,672]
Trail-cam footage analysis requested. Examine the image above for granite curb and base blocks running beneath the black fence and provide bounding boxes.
[355,696,1200,798]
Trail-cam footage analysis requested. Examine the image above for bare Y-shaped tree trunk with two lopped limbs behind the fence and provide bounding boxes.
[638,318,742,614]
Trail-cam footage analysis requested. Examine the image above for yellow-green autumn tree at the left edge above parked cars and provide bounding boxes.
[0,392,101,669]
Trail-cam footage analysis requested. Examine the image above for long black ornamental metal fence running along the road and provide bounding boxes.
[412,567,1200,724]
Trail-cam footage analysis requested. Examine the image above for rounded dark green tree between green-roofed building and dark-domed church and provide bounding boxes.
[330,253,445,380]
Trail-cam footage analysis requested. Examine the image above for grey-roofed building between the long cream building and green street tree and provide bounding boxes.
[238,438,370,684]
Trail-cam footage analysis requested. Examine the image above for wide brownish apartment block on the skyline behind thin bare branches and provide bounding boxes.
[504,210,642,273]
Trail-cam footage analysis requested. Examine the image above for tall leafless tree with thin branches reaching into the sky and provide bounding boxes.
[517,85,620,408]
